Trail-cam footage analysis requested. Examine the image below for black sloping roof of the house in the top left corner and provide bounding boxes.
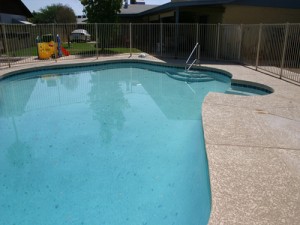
[0,0,32,17]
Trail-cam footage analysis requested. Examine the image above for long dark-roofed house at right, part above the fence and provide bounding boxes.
[120,0,300,24]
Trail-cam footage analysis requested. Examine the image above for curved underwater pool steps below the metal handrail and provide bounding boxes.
[166,72,214,82]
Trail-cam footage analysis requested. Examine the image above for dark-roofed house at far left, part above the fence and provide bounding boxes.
[0,0,32,24]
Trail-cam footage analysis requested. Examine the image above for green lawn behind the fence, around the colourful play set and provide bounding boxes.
[10,43,141,57]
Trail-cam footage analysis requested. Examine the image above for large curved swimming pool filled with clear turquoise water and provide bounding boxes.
[0,63,270,225]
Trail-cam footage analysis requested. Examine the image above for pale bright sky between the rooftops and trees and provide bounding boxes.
[22,0,170,15]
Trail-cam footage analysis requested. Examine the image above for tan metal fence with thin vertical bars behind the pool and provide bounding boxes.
[0,23,300,83]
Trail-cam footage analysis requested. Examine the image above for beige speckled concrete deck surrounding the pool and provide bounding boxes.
[0,55,300,225]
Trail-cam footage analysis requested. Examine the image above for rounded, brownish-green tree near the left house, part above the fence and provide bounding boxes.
[31,4,76,23]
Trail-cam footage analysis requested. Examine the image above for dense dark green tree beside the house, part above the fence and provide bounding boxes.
[81,0,123,23]
